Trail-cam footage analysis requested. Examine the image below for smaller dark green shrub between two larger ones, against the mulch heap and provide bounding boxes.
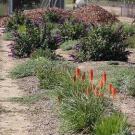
[59,19,87,40]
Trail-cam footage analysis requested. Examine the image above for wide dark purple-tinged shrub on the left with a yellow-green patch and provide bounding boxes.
[11,22,58,57]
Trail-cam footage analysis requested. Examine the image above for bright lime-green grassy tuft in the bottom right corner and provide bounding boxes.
[96,113,131,135]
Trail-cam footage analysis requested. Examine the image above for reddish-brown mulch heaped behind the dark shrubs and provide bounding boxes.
[0,5,118,27]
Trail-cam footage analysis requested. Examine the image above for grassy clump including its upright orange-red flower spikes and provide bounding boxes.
[58,68,116,134]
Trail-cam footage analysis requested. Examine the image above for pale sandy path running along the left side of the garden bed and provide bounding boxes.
[0,30,30,135]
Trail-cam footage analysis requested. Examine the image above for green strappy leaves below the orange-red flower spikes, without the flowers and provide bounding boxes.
[60,95,107,134]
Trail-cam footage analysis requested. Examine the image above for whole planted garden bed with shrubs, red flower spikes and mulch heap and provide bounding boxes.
[1,5,135,135]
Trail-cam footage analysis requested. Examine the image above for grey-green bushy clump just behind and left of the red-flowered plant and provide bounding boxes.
[35,61,74,89]
